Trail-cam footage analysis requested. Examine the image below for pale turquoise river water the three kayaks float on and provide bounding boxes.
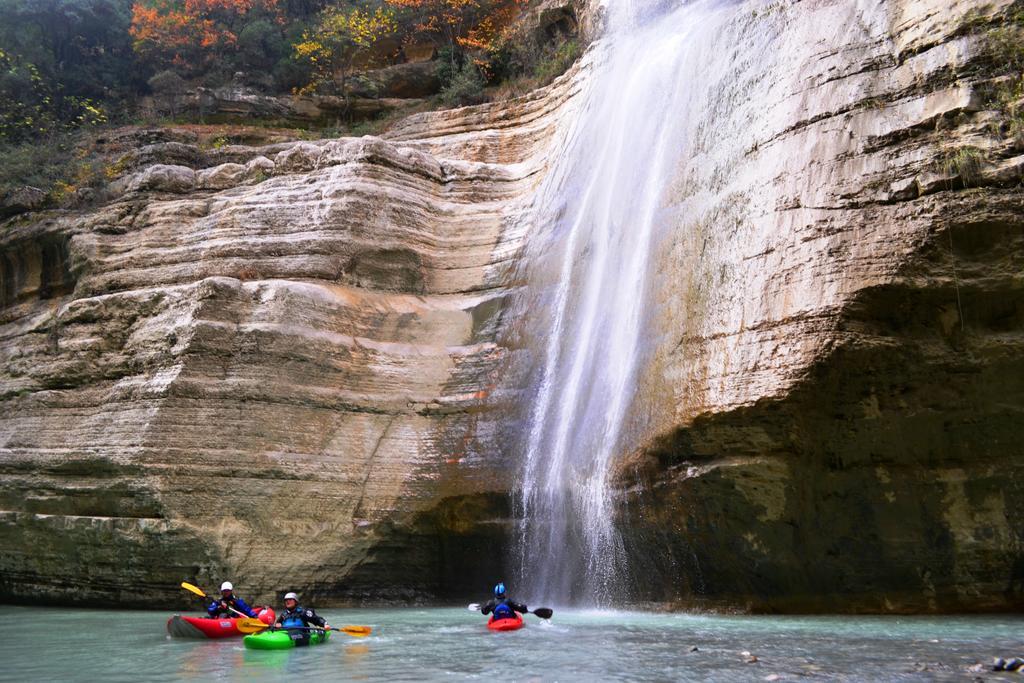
[0,606,1024,682]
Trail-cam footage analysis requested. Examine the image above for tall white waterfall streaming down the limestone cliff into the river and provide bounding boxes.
[517,0,730,604]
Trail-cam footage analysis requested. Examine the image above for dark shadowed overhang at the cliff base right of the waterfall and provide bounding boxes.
[621,193,1024,612]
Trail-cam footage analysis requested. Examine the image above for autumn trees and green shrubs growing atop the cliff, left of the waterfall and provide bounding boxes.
[0,0,580,210]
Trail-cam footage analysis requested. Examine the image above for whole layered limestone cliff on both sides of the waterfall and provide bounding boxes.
[0,0,1024,610]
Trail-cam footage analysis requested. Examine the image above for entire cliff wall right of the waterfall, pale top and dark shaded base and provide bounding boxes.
[620,0,1024,611]
